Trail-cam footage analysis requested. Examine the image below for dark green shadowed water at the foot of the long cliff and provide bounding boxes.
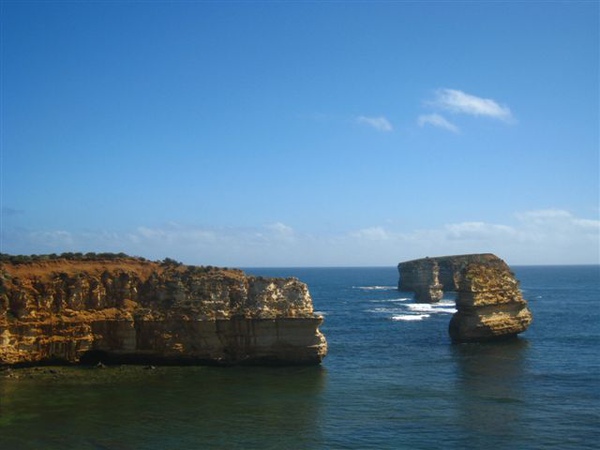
[0,367,326,449]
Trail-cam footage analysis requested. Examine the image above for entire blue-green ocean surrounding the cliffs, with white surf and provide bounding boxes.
[0,266,600,450]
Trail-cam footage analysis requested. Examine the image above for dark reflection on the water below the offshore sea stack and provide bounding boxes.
[452,338,529,448]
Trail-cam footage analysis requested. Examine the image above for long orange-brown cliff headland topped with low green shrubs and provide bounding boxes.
[0,255,327,365]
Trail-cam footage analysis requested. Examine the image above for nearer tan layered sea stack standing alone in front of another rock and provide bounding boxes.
[449,258,532,342]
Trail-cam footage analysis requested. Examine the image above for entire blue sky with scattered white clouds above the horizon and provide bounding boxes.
[0,0,600,267]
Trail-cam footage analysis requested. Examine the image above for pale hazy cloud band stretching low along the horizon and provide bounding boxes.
[2,209,600,267]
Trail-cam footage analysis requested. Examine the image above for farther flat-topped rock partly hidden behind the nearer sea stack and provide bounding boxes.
[398,253,499,303]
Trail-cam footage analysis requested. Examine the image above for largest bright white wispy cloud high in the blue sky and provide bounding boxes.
[431,89,513,122]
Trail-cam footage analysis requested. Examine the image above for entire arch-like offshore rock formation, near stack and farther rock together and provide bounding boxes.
[398,253,532,342]
